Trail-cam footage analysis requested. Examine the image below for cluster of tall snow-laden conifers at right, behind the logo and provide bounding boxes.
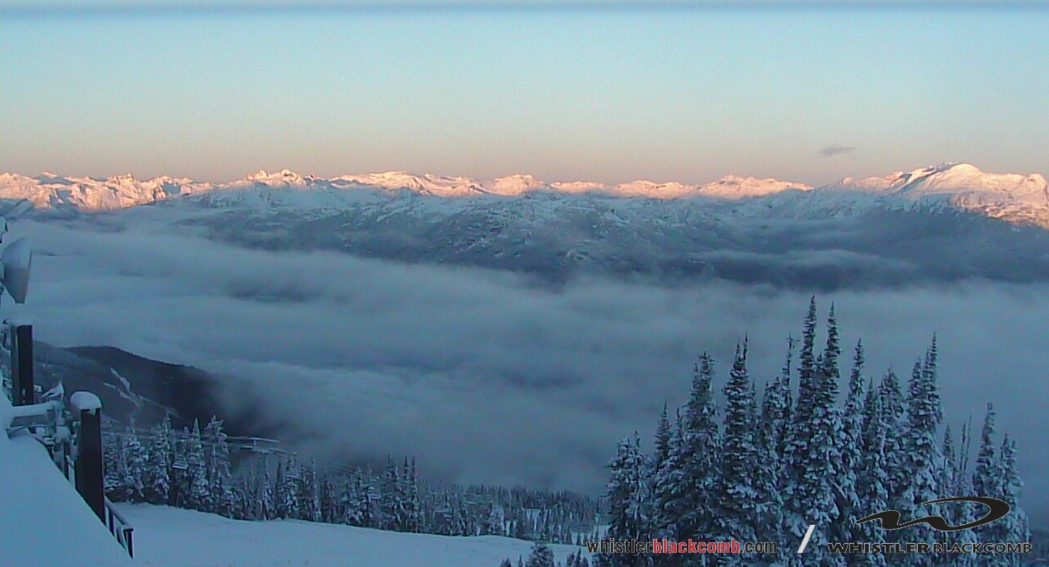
[594,299,1030,567]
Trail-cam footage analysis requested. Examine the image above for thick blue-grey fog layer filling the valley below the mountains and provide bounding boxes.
[3,220,1049,526]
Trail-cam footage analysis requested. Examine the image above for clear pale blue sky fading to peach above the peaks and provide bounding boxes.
[0,0,1049,183]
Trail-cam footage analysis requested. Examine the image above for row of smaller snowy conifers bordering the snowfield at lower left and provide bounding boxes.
[103,418,601,543]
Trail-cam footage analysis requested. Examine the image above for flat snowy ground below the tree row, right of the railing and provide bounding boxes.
[117,504,577,567]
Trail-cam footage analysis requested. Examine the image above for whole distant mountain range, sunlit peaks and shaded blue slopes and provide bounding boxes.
[0,163,1049,289]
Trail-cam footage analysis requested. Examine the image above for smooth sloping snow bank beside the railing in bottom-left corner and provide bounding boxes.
[0,395,132,567]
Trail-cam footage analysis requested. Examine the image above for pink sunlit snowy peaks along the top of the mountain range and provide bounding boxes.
[0,163,1049,224]
